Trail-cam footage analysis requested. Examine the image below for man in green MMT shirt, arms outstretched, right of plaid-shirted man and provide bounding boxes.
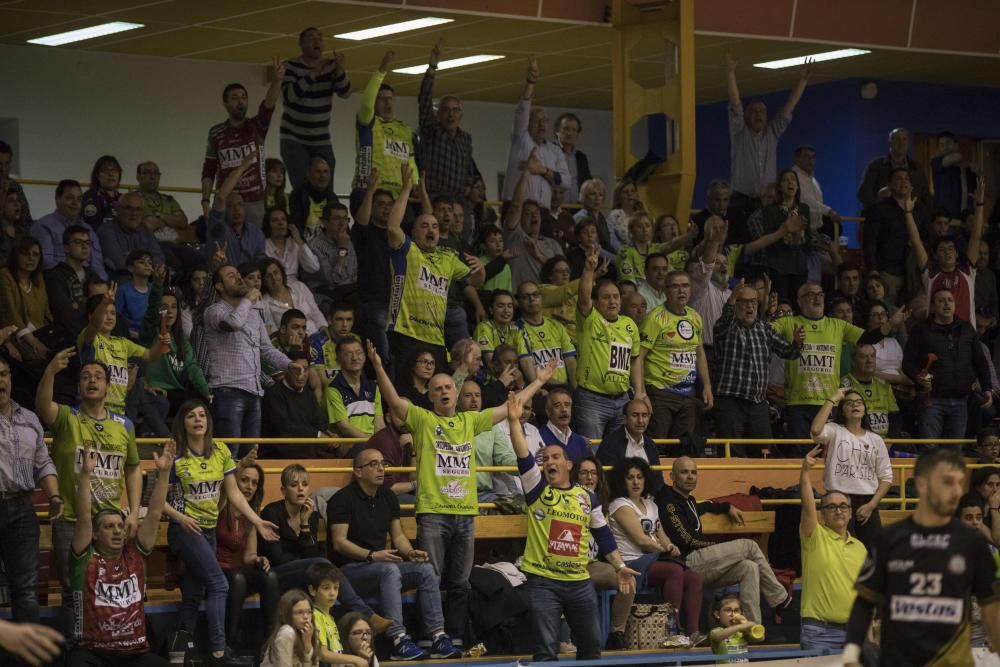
[771,282,864,456]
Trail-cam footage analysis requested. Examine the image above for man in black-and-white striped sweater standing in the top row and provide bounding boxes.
[281,28,351,188]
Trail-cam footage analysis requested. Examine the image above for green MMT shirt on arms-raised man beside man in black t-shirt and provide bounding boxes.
[388,237,469,346]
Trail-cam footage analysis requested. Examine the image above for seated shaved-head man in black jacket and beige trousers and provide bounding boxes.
[656,456,792,623]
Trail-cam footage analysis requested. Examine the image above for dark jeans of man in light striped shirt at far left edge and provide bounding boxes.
[0,492,39,623]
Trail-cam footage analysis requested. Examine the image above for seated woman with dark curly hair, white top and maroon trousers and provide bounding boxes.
[608,457,704,647]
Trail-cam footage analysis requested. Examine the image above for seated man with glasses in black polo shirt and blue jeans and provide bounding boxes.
[326,449,461,660]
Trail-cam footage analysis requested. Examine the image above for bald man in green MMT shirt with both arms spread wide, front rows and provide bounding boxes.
[368,340,555,640]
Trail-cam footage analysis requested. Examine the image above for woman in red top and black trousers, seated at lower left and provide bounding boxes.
[215,457,281,646]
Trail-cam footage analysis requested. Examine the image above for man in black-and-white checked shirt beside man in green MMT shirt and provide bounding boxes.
[713,280,805,455]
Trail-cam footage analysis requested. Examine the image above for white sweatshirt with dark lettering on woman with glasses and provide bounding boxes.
[816,422,892,496]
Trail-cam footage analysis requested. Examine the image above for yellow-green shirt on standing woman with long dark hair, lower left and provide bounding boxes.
[170,440,236,528]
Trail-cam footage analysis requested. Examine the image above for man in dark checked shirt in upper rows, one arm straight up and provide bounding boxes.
[417,41,482,200]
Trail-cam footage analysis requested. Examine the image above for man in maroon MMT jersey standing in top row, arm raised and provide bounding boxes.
[201,57,285,227]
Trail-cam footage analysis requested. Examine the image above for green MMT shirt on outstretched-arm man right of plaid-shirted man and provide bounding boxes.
[771,315,864,405]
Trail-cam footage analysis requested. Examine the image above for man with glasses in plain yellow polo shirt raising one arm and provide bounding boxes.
[799,446,868,651]
